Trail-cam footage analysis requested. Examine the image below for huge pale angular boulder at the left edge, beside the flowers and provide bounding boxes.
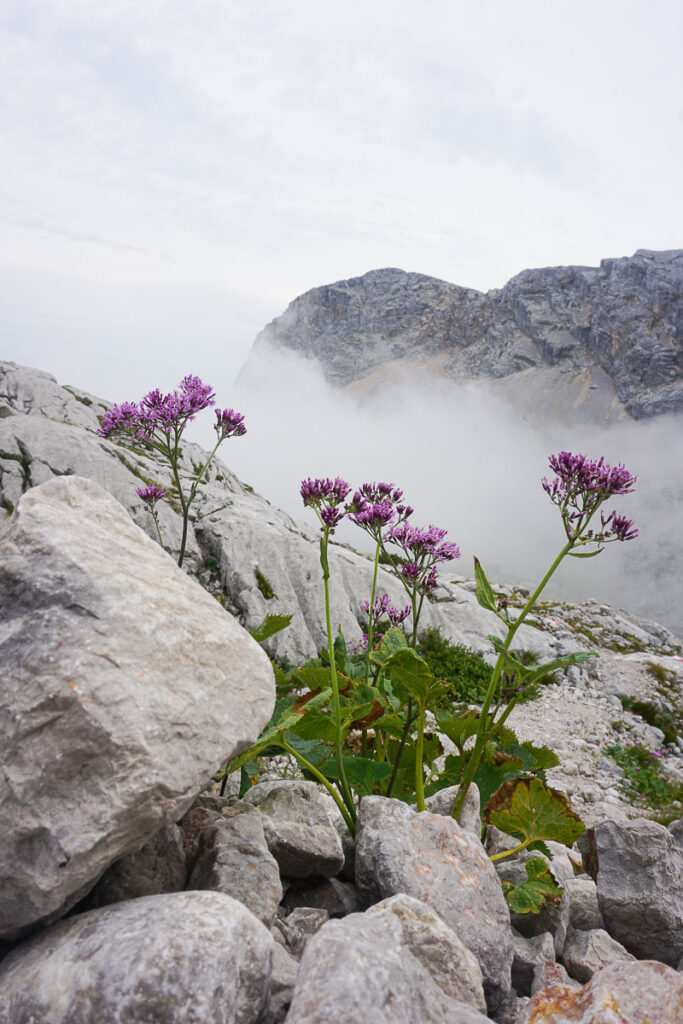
[0,477,274,939]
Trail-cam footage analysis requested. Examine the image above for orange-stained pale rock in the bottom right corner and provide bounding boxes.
[517,961,683,1024]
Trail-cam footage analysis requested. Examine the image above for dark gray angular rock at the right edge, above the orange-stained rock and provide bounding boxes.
[578,818,683,967]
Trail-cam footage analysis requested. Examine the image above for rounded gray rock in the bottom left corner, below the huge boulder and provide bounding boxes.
[0,893,273,1024]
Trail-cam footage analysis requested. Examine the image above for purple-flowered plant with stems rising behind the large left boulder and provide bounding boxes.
[98,375,247,565]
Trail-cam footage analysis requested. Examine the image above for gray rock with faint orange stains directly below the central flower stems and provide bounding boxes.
[356,797,513,1009]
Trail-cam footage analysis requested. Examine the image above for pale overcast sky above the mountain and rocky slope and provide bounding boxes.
[0,0,683,403]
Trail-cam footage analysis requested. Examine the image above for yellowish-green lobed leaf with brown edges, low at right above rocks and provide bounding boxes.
[483,778,586,846]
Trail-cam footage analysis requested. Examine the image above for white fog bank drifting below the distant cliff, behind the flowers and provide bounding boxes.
[204,351,683,637]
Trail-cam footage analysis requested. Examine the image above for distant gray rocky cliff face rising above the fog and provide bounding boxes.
[248,250,683,422]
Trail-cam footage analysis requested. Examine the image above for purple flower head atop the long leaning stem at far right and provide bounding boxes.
[541,452,638,544]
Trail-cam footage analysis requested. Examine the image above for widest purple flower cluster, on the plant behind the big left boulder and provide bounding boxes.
[98,375,220,444]
